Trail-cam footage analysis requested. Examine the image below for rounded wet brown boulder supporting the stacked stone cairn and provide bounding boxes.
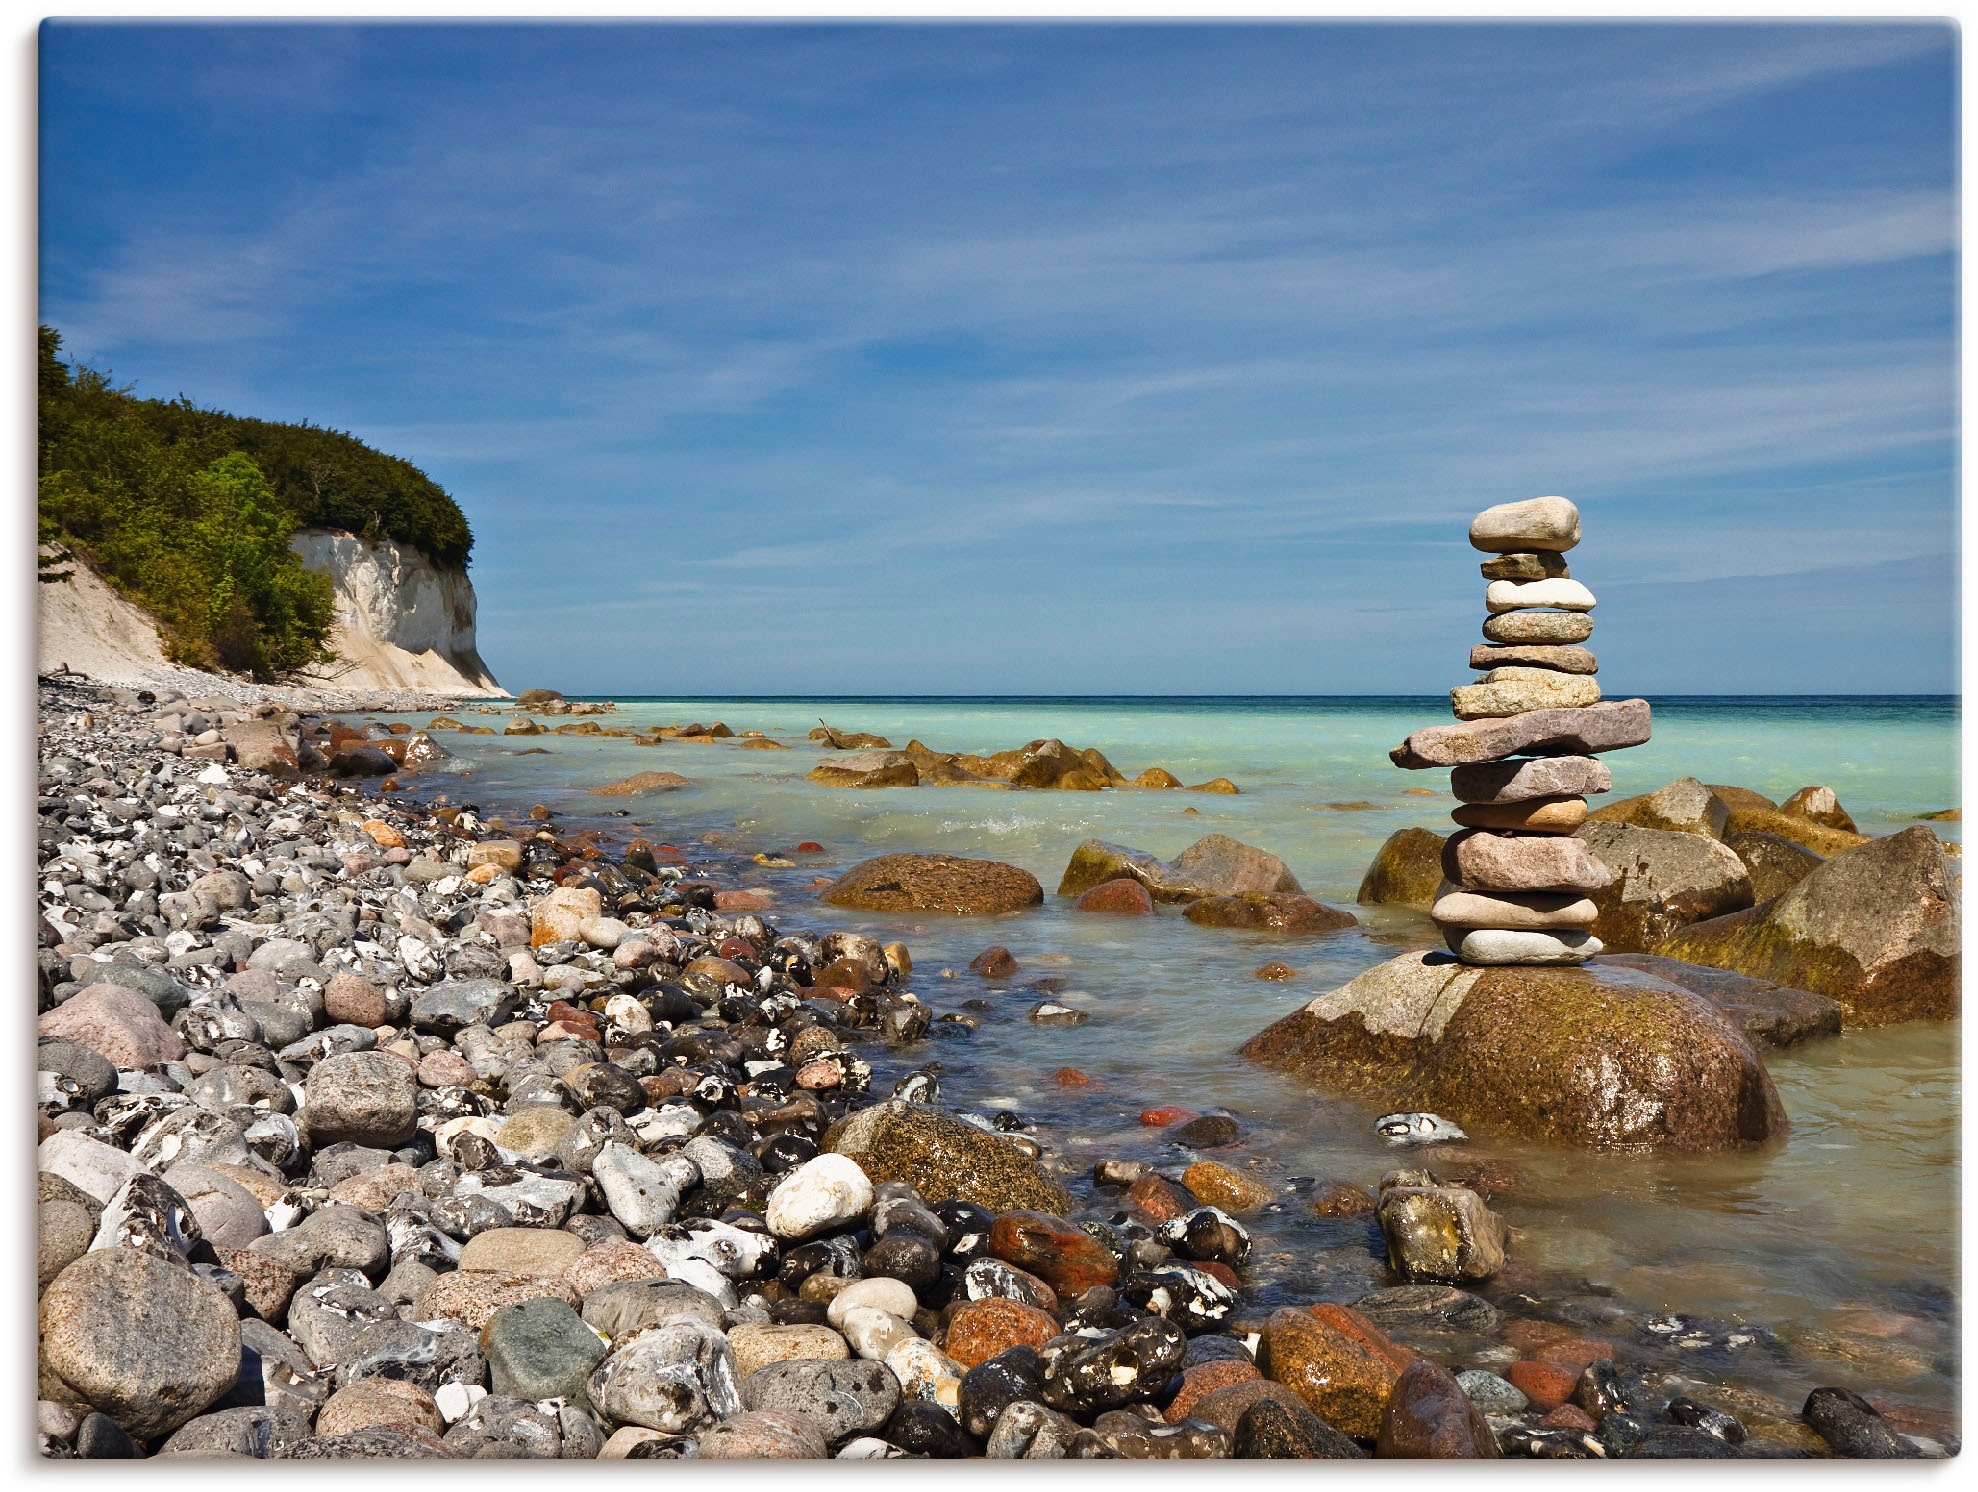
[1242,952,1786,1152]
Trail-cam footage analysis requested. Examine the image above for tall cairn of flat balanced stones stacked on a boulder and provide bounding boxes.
[1389,497,1650,964]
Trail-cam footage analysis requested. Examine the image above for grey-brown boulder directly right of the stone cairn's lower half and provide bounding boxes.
[1574,819,1753,952]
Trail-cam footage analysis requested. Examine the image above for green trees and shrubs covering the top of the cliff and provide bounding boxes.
[40,326,473,679]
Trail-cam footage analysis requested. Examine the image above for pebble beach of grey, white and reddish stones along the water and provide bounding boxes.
[38,679,1958,1460]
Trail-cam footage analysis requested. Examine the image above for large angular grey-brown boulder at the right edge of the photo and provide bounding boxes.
[1656,815,1962,1027]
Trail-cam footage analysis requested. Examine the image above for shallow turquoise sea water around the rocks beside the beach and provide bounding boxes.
[377,699,1960,1415]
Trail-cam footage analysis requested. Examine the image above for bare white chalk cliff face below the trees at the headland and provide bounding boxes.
[289,528,506,695]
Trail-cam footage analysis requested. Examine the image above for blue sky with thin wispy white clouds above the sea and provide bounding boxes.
[40,24,1958,695]
